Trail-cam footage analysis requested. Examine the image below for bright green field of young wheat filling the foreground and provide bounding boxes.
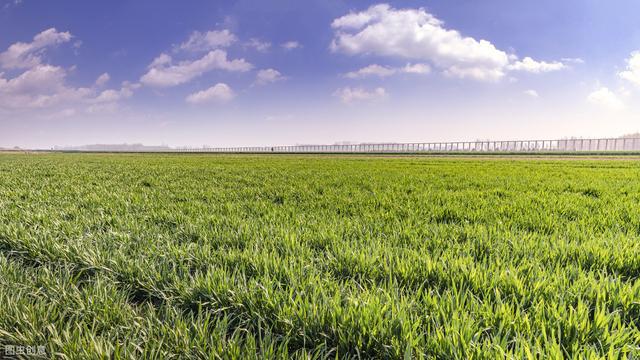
[0,154,640,359]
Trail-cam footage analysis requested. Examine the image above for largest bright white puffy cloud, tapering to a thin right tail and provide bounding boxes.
[330,4,558,81]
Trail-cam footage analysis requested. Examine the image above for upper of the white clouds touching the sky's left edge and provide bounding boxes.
[0,28,72,69]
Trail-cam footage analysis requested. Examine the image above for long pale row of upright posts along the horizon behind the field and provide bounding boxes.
[169,138,640,153]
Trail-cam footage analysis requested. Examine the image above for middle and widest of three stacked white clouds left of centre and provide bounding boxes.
[140,49,253,87]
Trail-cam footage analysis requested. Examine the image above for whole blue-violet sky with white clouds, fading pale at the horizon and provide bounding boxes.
[0,0,640,148]
